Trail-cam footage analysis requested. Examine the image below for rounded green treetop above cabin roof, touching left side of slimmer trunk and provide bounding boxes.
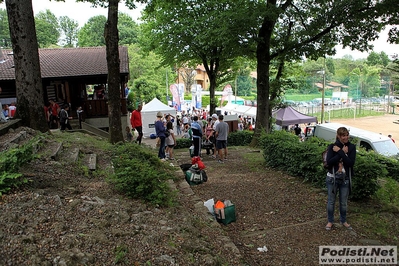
[78,15,107,47]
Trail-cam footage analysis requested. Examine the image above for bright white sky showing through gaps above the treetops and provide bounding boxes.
[0,0,399,59]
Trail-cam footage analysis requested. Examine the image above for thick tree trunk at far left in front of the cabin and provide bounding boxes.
[6,0,49,132]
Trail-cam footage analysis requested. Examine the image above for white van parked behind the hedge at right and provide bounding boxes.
[313,123,399,156]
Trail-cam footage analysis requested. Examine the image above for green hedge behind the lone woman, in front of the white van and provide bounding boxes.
[260,131,399,200]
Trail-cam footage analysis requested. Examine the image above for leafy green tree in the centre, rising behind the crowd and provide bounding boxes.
[142,0,252,112]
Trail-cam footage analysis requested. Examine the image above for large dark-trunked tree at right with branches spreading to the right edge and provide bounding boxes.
[249,0,398,144]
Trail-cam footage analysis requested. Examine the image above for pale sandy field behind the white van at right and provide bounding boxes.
[331,114,399,147]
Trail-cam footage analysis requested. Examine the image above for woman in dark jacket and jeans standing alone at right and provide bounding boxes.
[326,127,356,230]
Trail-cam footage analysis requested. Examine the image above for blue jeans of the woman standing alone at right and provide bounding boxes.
[326,176,349,223]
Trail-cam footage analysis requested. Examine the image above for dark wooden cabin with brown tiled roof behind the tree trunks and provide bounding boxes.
[0,46,129,118]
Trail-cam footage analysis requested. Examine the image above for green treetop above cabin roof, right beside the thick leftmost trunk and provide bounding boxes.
[35,9,61,48]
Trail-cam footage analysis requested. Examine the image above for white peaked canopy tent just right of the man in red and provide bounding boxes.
[141,98,176,137]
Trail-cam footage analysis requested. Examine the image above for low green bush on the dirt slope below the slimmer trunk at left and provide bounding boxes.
[108,144,175,206]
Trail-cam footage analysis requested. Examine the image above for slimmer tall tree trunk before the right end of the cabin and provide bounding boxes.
[104,0,123,143]
